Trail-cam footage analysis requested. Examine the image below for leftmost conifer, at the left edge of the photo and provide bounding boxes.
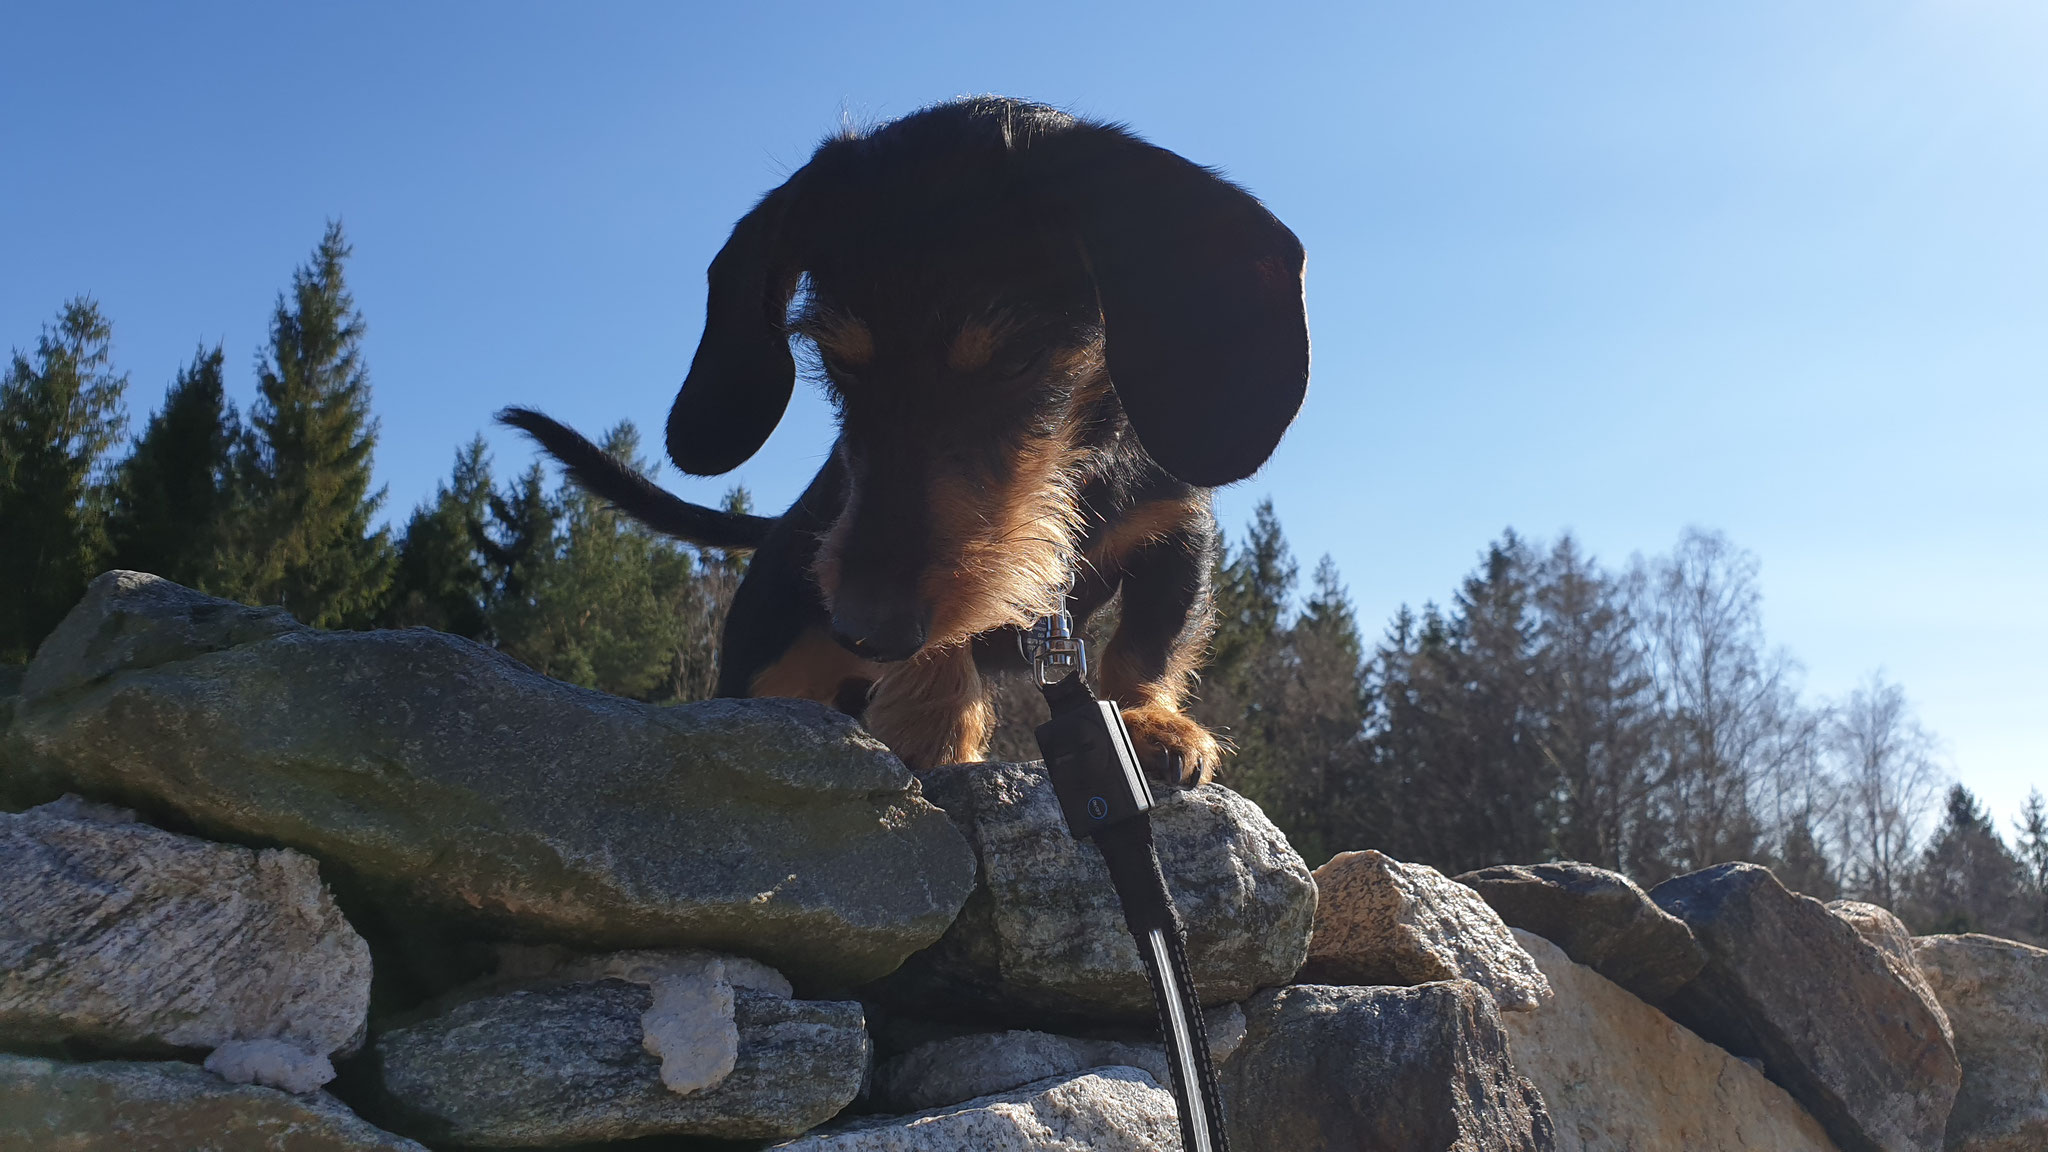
[0,297,127,664]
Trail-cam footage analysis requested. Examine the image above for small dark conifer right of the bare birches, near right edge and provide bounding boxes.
[1907,783,2025,935]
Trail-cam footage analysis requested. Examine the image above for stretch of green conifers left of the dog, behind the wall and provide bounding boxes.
[0,223,745,701]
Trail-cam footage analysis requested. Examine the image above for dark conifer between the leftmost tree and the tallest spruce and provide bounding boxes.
[109,344,240,590]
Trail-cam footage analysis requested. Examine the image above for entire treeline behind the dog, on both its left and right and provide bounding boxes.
[0,225,2048,939]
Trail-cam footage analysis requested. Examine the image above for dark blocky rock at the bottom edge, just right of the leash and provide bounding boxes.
[1221,980,1554,1152]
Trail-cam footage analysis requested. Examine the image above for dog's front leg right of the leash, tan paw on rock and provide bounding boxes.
[1098,525,1223,787]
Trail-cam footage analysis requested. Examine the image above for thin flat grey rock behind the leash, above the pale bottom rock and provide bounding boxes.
[868,1004,1245,1113]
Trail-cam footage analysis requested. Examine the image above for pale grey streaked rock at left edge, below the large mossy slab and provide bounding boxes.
[0,783,371,1091]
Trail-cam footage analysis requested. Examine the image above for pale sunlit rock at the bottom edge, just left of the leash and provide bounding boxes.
[776,1068,1180,1152]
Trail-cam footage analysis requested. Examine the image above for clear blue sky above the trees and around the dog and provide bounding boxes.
[0,0,2048,814]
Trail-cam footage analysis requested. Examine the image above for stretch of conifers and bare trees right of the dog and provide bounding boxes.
[1196,502,2048,939]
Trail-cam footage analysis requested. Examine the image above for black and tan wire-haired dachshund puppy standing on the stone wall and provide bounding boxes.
[512,98,1309,783]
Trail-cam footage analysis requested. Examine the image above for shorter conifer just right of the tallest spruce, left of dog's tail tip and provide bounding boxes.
[385,437,492,640]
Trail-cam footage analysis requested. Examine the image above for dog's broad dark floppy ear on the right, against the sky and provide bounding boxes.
[1034,127,1309,488]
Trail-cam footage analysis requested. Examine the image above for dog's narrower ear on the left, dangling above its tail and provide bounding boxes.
[668,172,803,476]
